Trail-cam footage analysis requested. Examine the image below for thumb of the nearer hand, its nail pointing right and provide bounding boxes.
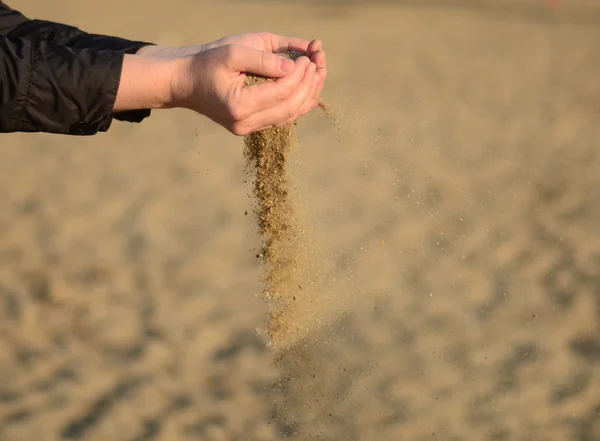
[229,46,296,78]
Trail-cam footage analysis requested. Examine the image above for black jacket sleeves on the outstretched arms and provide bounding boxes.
[0,1,151,136]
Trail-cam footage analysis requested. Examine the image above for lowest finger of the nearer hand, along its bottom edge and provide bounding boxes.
[243,63,316,131]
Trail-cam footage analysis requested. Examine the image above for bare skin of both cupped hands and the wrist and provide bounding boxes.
[114,33,327,136]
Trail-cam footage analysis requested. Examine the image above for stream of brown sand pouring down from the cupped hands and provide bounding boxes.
[244,53,372,441]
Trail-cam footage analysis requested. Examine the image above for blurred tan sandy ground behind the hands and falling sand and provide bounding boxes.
[0,0,600,441]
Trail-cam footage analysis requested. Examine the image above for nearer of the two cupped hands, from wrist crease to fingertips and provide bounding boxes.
[171,44,320,136]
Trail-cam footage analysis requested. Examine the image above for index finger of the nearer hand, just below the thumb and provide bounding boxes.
[240,57,314,113]
